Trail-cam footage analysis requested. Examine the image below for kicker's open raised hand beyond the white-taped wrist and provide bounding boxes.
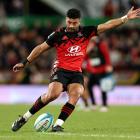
[127,7,140,19]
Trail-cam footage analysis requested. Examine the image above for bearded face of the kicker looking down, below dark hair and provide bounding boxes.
[66,17,80,32]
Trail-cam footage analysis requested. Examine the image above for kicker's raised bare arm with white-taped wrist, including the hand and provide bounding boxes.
[97,7,140,34]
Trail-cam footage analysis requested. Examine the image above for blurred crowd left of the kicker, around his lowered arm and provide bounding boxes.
[0,25,55,83]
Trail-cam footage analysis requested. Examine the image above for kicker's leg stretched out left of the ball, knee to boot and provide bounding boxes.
[12,82,63,131]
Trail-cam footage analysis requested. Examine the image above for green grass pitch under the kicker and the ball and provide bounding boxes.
[0,105,140,140]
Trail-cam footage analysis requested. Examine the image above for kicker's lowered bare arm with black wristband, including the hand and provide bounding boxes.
[13,42,49,72]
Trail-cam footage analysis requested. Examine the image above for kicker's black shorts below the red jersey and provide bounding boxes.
[50,68,84,90]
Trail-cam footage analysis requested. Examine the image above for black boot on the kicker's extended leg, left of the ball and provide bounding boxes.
[12,116,27,132]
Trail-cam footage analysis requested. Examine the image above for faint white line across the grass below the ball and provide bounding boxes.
[0,133,140,139]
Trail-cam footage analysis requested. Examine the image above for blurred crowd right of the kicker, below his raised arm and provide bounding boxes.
[106,27,140,70]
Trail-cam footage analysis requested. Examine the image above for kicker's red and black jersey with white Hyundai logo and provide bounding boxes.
[46,26,97,72]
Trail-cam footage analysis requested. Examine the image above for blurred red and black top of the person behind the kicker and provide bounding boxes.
[85,40,111,74]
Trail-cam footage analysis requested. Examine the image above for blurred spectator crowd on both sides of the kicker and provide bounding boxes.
[0,25,140,84]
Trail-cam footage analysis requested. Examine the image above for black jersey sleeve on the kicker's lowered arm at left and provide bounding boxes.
[46,32,58,47]
